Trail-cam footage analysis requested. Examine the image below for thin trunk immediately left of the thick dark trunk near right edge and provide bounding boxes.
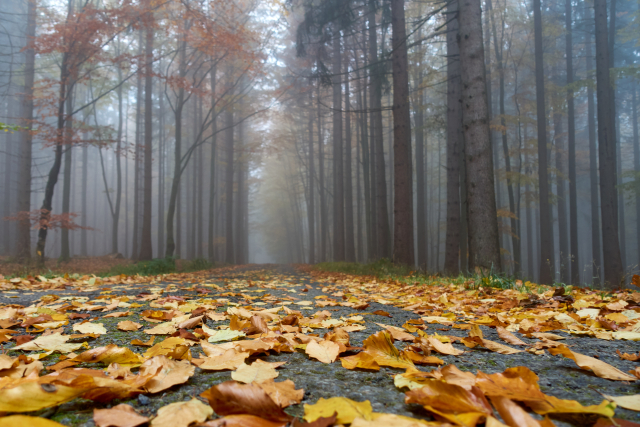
[586,31,602,285]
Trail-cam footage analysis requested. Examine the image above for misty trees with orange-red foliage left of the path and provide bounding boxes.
[2,0,271,263]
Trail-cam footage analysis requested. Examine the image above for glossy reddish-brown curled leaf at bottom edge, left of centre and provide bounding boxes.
[200,381,293,423]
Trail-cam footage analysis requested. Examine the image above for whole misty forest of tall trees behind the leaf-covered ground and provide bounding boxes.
[0,0,640,286]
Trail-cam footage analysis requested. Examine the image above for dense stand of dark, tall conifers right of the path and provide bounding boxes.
[264,0,640,287]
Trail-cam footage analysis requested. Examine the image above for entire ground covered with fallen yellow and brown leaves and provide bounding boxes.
[0,265,640,427]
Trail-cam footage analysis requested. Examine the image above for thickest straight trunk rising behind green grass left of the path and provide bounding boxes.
[139,23,154,260]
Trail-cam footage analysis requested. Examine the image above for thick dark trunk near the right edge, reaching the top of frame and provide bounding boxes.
[594,0,623,289]
